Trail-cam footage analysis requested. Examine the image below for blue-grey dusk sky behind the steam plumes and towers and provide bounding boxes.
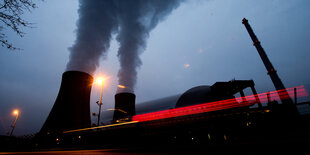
[0,0,310,135]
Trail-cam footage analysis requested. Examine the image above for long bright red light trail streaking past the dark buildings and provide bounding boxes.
[132,86,308,122]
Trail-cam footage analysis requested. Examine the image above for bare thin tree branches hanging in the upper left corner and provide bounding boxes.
[0,0,37,50]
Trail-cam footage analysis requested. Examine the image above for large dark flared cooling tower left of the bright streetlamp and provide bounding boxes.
[40,71,93,133]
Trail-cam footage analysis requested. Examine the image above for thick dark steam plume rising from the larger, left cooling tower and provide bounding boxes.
[67,0,118,74]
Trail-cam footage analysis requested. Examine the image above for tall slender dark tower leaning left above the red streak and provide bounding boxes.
[242,18,293,104]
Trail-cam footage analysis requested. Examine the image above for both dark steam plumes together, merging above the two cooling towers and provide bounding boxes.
[67,0,183,92]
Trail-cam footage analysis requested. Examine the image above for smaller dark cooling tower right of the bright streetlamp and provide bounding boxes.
[113,93,136,122]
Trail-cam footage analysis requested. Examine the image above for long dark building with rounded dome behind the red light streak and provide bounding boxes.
[136,80,259,114]
